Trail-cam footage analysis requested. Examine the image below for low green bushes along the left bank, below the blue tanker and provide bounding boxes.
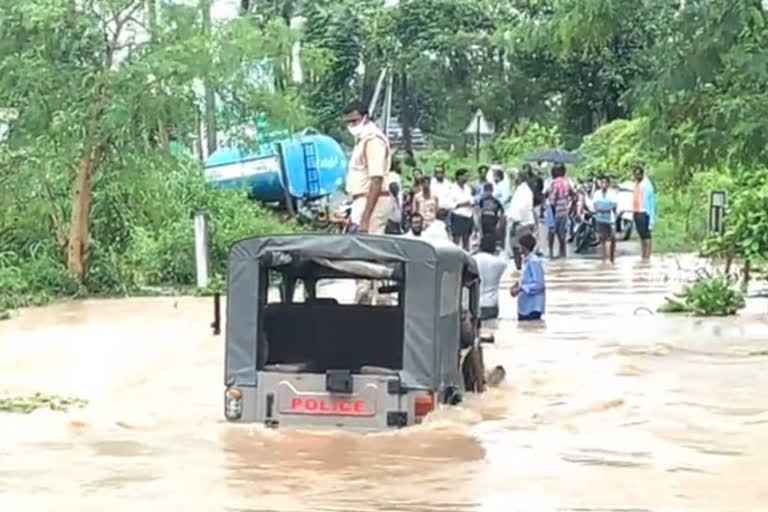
[0,147,298,310]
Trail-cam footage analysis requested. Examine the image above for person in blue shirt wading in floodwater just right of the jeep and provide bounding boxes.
[510,233,546,322]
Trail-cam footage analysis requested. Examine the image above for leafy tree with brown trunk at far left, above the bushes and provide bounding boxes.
[0,0,303,280]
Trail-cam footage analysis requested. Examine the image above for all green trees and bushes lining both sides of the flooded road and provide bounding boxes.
[0,0,768,318]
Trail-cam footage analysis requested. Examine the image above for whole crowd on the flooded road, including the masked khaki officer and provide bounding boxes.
[344,102,655,321]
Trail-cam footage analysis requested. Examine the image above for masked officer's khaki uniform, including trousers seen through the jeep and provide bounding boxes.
[347,123,394,304]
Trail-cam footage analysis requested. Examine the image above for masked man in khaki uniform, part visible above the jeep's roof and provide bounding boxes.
[343,101,392,235]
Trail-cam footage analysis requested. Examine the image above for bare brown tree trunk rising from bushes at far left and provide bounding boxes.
[67,148,102,280]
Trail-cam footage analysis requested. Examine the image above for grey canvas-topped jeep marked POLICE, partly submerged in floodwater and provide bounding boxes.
[224,235,484,430]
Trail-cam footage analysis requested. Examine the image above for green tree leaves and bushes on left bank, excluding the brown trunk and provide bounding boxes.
[0,0,312,310]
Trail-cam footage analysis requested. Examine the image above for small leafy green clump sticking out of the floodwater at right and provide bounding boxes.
[659,276,746,316]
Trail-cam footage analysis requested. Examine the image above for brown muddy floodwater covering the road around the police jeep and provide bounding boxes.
[0,254,768,512]
